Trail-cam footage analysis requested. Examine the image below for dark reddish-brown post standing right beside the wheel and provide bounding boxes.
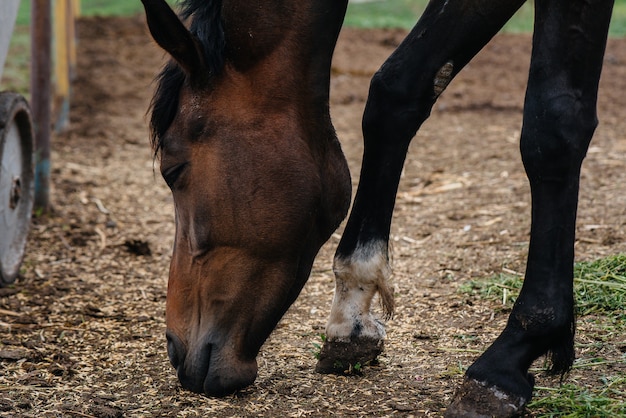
[30,0,52,212]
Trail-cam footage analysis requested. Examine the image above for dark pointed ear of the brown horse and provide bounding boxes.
[141,0,203,75]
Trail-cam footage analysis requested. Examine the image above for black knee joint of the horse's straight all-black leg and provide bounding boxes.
[520,86,598,182]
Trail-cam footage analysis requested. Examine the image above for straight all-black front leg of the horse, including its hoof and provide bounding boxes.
[446,0,613,417]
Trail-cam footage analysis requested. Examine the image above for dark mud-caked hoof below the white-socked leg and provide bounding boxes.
[315,337,384,375]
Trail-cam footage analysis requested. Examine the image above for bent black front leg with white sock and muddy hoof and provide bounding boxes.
[316,0,524,373]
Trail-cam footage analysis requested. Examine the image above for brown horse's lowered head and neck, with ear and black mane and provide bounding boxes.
[142,0,351,396]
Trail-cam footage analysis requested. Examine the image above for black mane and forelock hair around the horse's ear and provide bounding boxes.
[150,0,225,156]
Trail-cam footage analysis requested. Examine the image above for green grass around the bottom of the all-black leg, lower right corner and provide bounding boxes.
[459,254,626,417]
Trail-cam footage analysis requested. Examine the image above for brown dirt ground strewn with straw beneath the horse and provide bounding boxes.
[0,17,626,417]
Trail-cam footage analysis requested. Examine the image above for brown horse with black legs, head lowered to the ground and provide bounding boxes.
[142,0,613,416]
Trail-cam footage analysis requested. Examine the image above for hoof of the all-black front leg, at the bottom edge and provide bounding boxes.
[444,378,528,418]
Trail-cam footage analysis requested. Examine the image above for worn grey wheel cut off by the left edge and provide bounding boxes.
[0,92,35,286]
